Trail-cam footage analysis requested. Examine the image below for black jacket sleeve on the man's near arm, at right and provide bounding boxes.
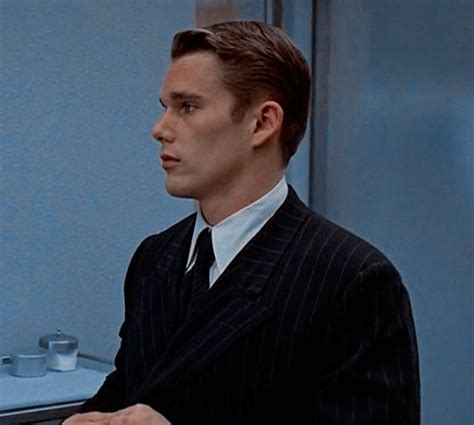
[317,261,420,425]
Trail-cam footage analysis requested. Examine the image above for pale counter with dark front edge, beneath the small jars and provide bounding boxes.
[0,358,113,425]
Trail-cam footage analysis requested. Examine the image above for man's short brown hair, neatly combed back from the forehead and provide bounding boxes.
[171,21,311,163]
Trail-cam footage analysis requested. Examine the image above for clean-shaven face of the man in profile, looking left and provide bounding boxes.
[153,52,252,201]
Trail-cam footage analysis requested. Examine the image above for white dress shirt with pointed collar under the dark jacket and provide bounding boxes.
[186,177,288,286]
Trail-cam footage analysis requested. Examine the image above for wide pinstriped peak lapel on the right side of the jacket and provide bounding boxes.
[131,187,309,402]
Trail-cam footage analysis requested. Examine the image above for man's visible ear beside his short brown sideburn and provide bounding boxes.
[252,100,283,147]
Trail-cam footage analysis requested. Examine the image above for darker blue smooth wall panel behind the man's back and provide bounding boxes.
[313,0,474,425]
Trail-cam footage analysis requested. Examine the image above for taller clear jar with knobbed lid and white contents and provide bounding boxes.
[39,328,79,372]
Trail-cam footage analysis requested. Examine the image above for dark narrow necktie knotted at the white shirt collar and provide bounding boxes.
[183,227,215,315]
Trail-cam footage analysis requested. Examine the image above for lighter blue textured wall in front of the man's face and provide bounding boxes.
[0,0,195,358]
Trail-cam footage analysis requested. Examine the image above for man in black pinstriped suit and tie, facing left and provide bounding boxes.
[65,22,419,425]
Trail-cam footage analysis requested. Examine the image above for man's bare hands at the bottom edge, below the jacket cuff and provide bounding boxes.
[63,404,171,425]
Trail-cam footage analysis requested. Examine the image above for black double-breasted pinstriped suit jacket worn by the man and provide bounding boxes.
[82,188,420,425]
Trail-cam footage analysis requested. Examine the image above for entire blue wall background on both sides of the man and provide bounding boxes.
[0,0,474,425]
